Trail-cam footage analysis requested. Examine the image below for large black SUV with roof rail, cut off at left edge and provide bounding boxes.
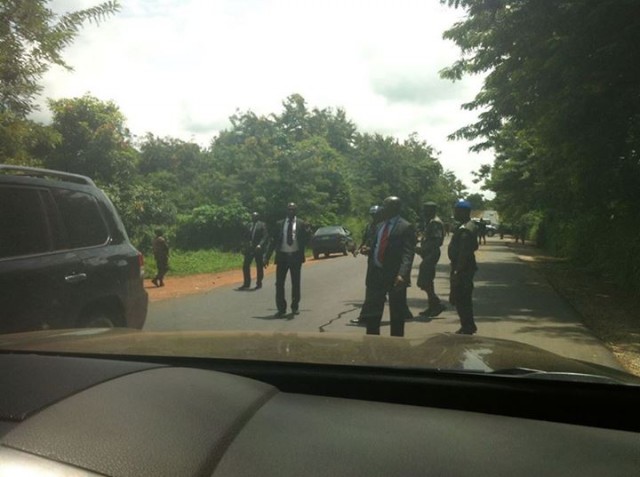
[0,165,148,333]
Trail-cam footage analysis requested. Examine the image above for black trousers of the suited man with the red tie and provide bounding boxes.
[360,266,408,336]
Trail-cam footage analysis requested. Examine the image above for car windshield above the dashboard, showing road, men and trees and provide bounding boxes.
[0,0,640,384]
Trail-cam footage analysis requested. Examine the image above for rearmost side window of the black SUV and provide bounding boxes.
[52,189,109,248]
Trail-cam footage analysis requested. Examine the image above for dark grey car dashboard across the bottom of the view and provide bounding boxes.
[0,353,640,477]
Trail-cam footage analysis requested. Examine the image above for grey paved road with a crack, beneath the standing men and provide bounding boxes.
[145,237,619,367]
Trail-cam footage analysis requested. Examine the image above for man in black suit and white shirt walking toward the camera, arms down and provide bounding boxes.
[266,202,311,316]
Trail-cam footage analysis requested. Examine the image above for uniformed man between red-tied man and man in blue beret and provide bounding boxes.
[418,202,445,317]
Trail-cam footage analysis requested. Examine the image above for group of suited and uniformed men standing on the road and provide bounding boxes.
[239,196,478,336]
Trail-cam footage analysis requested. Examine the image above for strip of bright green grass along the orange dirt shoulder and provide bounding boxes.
[144,250,243,278]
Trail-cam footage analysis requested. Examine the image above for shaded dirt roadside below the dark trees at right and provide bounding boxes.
[505,242,640,376]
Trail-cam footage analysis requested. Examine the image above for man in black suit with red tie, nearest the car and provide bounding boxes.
[361,196,416,336]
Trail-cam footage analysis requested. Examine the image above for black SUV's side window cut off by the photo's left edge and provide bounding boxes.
[0,186,51,258]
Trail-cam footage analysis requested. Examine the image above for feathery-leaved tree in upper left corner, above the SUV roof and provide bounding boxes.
[0,0,120,166]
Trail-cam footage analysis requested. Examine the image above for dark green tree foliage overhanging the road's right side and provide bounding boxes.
[442,0,640,288]
